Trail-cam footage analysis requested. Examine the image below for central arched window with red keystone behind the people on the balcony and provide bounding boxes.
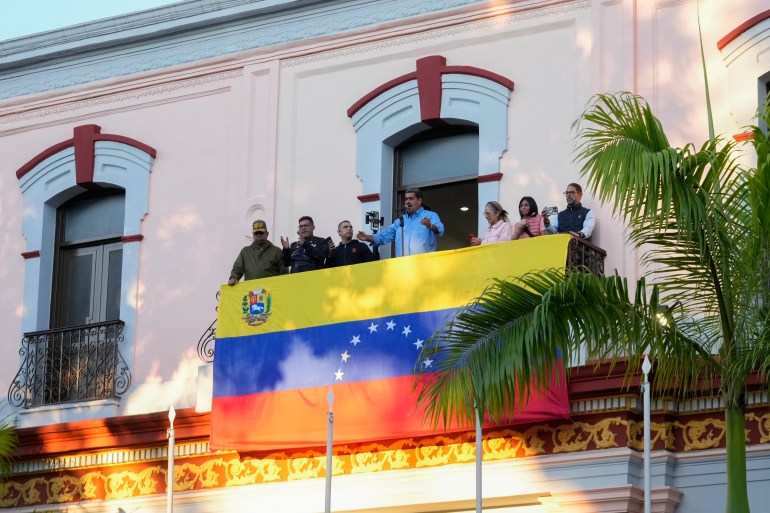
[348,55,513,254]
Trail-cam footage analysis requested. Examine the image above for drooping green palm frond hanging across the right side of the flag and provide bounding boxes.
[416,270,713,426]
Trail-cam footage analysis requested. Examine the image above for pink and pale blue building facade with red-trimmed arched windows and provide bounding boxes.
[0,0,770,513]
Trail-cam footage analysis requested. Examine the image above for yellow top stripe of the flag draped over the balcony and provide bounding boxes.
[217,235,570,338]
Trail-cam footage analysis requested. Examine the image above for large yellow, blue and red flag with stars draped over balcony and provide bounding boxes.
[211,236,569,450]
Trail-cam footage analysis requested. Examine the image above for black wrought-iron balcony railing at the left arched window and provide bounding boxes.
[8,321,131,408]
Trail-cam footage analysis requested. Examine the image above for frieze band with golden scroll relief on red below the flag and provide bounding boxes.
[6,413,770,507]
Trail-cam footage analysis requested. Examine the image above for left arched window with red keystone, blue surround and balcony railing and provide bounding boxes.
[8,125,155,412]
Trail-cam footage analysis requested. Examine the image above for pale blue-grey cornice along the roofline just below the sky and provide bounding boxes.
[0,0,484,99]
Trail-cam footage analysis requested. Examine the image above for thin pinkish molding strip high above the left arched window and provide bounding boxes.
[0,68,243,125]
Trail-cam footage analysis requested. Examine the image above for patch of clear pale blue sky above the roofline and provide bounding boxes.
[0,0,183,41]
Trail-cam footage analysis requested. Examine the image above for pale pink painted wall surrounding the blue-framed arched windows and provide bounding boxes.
[0,0,759,422]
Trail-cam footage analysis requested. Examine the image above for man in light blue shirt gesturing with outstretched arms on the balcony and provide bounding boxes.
[356,188,444,256]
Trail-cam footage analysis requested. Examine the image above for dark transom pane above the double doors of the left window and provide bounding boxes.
[64,194,125,242]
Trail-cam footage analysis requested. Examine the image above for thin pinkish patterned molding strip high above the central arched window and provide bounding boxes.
[281,0,591,68]
